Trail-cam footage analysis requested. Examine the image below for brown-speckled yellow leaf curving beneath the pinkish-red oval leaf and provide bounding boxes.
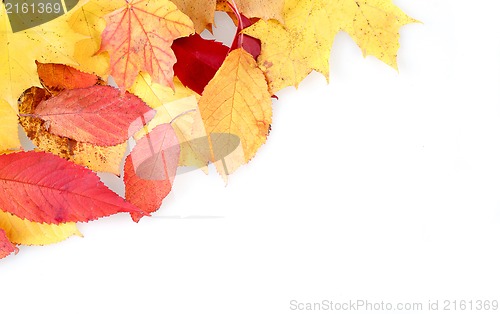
[19,87,127,175]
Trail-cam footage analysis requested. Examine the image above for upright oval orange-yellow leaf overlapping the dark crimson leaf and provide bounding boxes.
[199,49,272,173]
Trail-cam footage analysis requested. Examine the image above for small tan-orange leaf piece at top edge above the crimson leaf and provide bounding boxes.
[171,0,216,34]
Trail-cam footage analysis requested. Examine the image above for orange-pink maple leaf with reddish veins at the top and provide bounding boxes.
[100,0,194,90]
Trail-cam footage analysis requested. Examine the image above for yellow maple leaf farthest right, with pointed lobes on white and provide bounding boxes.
[244,0,416,93]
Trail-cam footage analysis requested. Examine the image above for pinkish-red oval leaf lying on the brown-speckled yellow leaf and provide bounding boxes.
[34,86,154,146]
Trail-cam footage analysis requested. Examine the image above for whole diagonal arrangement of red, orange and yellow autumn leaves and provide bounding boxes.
[0,0,417,258]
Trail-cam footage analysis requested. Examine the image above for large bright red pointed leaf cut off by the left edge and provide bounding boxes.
[0,151,141,224]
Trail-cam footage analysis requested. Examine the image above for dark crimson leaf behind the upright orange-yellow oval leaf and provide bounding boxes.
[172,34,229,95]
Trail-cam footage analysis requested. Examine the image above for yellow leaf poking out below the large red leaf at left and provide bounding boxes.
[0,210,82,245]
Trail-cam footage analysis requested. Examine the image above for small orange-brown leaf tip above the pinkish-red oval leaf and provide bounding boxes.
[35,61,99,91]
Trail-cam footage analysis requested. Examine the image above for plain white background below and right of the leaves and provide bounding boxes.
[0,0,500,314]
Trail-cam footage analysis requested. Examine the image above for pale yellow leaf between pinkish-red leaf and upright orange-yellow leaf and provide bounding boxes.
[129,72,208,168]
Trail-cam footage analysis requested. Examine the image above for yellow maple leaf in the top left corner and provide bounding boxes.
[0,1,108,150]
